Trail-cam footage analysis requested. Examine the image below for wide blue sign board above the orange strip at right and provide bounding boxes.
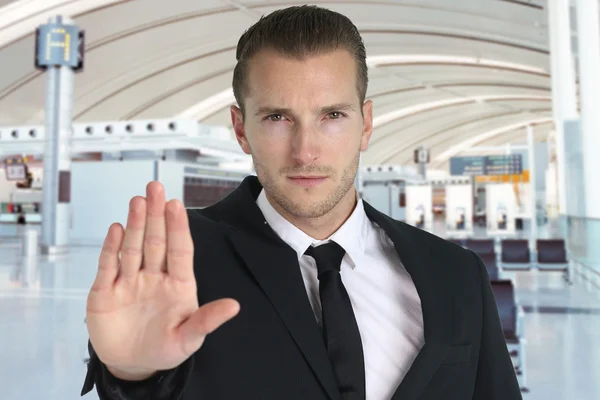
[450,154,523,176]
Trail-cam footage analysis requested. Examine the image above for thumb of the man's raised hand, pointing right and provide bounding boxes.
[179,299,240,354]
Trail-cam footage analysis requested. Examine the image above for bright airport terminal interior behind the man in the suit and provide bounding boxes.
[0,0,600,400]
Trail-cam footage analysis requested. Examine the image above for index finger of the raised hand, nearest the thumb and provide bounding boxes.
[165,200,194,281]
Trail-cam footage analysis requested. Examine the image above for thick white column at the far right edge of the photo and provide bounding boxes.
[577,0,600,219]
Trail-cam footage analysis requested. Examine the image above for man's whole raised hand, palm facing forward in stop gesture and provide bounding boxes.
[86,182,239,380]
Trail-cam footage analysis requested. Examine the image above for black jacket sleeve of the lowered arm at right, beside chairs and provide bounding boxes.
[472,253,523,400]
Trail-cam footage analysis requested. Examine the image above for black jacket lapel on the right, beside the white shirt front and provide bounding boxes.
[365,203,452,400]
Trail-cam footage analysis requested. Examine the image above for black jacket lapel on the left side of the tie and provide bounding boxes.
[206,177,341,400]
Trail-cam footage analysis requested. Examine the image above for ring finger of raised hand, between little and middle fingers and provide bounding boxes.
[120,196,146,277]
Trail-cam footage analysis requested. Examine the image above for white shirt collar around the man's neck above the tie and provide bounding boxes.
[256,189,369,268]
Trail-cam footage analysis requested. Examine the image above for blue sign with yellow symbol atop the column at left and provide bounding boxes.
[35,23,84,70]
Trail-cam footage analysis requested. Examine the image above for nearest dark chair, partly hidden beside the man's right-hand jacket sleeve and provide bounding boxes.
[490,279,529,392]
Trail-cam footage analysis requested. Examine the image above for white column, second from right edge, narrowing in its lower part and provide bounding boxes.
[547,0,578,215]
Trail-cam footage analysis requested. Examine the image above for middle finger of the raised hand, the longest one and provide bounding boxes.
[143,181,167,272]
